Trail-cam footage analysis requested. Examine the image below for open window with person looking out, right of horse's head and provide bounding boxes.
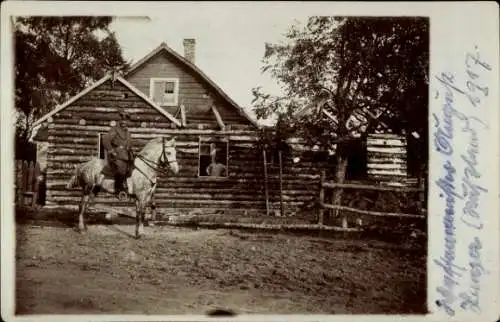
[198,139,229,178]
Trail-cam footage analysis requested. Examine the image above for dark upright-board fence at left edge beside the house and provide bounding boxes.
[15,160,40,207]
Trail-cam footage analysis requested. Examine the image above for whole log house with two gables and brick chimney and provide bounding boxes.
[33,39,328,213]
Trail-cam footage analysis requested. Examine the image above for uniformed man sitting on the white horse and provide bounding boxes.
[102,111,133,198]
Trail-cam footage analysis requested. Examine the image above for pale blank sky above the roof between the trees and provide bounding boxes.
[110,7,307,123]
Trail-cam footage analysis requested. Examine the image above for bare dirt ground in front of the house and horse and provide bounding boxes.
[16,208,426,314]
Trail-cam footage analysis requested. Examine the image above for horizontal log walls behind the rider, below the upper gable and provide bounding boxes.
[46,78,319,212]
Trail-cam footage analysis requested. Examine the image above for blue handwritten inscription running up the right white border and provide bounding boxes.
[433,47,491,316]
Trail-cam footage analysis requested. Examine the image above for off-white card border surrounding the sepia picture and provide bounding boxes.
[1,1,500,321]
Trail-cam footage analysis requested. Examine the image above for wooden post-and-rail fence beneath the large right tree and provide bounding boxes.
[318,171,426,226]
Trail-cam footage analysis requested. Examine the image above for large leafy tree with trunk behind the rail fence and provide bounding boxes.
[253,17,429,214]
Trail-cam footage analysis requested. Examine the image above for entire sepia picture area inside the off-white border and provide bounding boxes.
[2,4,496,317]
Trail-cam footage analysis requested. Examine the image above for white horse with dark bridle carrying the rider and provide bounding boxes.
[66,137,179,238]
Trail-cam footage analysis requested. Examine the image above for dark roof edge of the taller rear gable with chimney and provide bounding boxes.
[125,42,260,128]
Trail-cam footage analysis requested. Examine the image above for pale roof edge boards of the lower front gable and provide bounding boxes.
[31,74,182,140]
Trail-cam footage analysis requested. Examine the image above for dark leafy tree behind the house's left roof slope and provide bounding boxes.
[14,16,129,142]
